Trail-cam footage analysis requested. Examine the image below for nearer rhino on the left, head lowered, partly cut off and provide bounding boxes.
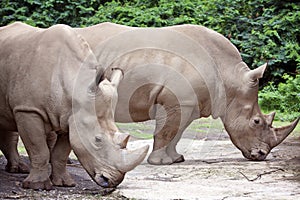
[0,22,148,190]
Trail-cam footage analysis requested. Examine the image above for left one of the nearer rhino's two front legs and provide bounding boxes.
[15,111,52,190]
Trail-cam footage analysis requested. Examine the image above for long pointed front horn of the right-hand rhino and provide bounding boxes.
[270,118,300,148]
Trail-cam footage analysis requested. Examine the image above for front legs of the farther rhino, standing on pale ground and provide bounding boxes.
[148,105,193,165]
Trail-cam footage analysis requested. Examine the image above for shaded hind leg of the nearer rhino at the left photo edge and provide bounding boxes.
[0,131,29,173]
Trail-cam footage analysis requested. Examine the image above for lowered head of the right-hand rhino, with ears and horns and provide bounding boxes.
[221,62,299,160]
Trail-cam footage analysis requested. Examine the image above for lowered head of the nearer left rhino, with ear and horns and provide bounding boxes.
[70,67,149,187]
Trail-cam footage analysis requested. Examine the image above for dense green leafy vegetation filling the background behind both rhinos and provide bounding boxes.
[0,0,300,119]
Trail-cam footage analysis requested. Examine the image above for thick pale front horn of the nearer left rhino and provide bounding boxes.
[116,145,149,173]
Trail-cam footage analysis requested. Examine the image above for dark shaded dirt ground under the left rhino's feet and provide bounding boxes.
[0,156,126,199]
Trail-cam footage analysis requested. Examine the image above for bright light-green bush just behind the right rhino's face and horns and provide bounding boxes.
[259,74,300,120]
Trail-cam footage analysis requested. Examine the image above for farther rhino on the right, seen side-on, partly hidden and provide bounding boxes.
[76,23,299,164]
